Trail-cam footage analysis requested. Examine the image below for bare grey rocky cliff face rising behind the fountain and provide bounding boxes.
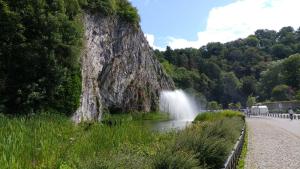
[73,12,174,122]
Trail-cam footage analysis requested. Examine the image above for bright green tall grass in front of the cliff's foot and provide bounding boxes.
[0,111,172,169]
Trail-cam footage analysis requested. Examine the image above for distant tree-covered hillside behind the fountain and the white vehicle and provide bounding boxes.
[156,27,300,107]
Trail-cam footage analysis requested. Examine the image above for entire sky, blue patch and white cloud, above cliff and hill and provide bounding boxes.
[130,0,300,50]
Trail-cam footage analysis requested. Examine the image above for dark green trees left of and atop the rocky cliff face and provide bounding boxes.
[0,0,139,114]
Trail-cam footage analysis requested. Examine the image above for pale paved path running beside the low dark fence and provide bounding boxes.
[245,117,300,169]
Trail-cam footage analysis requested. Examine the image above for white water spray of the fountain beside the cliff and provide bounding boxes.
[159,90,200,121]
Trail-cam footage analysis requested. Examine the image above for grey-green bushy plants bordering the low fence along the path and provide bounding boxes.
[154,111,244,169]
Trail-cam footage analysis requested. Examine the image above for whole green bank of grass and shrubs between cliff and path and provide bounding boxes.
[0,110,244,169]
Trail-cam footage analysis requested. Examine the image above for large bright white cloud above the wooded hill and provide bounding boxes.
[168,0,300,49]
